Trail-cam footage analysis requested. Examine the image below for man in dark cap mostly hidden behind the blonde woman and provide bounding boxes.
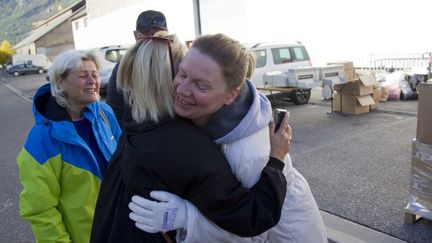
[106,10,168,128]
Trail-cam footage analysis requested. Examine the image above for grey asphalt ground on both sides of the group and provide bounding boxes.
[0,71,432,242]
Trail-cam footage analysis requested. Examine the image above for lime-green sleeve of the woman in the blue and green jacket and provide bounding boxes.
[17,141,71,242]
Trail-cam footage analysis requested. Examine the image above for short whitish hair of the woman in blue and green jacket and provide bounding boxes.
[48,50,101,108]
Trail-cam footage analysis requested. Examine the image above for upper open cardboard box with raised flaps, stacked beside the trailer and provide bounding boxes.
[334,74,378,96]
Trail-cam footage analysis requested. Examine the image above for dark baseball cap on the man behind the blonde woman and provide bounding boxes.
[136,10,168,34]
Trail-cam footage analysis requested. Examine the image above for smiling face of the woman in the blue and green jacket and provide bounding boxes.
[59,61,100,110]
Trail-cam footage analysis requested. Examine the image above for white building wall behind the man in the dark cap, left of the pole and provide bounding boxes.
[73,0,196,49]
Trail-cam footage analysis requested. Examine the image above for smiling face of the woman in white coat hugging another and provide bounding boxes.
[173,48,239,127]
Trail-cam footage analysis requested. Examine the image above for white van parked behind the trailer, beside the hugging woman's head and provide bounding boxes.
[245,41,312,105]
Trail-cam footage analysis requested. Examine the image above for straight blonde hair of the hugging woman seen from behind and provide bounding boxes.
[117,31,186,123]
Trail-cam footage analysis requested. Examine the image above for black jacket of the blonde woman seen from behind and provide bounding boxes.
[91,119,286,243]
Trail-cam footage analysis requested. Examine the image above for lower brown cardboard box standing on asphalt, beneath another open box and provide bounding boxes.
[341,93,375,115]
